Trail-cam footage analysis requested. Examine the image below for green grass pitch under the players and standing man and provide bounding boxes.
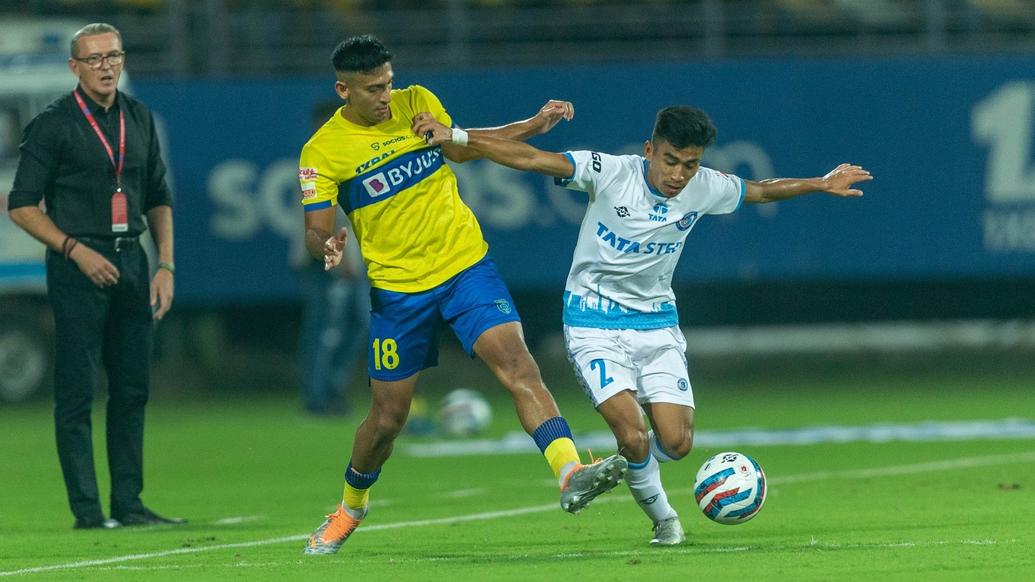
[0,352,1035,582]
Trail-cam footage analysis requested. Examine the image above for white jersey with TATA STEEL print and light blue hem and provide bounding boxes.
[558,151,744,329]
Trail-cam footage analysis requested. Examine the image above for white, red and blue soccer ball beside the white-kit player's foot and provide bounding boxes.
[693,452,766,525]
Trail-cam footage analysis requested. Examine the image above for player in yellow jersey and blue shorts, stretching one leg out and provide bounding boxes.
[298,35,627,554]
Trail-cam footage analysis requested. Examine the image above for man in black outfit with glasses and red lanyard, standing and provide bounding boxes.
[8,24,183,528]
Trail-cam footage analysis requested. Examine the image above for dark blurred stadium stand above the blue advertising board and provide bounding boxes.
[8,0,1035,78]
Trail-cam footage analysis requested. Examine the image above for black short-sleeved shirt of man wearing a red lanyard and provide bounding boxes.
[7,89,172,236]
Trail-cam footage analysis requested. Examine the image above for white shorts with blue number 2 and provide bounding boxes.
[564,325,693,408]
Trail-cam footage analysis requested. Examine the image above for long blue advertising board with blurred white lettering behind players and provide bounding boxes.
[127,57,1035,302]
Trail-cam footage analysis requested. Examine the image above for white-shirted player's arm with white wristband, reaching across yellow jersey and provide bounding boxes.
[413,116,574,178]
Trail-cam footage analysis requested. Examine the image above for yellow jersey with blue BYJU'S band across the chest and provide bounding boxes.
[298,85,489,293]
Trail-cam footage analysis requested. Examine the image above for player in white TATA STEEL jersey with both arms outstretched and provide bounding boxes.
[414,107,873,546]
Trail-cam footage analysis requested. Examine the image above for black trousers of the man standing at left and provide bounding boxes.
[47,239,153,519]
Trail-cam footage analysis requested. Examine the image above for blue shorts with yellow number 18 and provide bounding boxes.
[366,257,521,381]
